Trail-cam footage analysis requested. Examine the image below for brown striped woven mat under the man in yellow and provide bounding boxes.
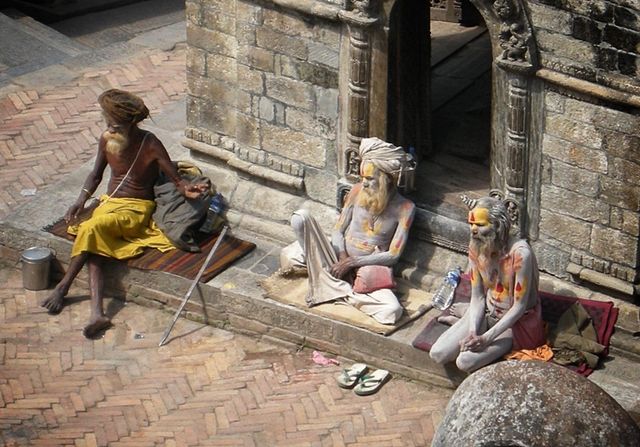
[44,213,256,282]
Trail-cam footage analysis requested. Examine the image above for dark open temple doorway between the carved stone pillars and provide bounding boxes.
[388,1,493,228]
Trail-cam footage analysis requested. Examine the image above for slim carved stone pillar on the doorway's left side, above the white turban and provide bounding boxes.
[338,8,378,187]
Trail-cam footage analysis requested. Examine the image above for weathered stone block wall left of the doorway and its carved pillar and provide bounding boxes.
[186,0,342,204]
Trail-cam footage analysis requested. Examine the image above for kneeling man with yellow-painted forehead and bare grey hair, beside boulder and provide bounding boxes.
[430,197,545,372]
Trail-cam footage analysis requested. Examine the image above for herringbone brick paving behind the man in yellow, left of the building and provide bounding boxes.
[0,44,186,218]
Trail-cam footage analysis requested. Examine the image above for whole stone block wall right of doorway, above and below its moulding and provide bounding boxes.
[525,0,640,292]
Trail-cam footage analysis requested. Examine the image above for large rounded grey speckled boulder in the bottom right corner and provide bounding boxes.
[431,360,640,447]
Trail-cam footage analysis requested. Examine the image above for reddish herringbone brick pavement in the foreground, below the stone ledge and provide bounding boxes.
[0,263,450,447]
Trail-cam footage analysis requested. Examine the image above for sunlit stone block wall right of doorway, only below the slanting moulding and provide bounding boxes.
[540,91,640,283]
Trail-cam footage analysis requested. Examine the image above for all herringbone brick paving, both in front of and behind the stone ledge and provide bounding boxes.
[0,12,450,447]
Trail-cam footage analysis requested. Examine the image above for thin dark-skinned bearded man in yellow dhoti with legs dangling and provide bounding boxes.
[42,89,209,337]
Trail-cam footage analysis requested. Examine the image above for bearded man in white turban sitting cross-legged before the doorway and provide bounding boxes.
[281,138,415,324]
